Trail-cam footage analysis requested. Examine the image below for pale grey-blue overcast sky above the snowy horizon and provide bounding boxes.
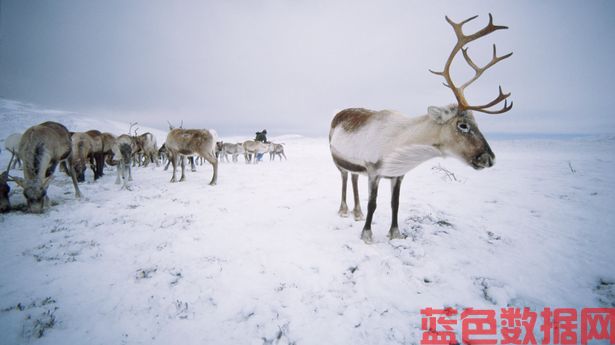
[0,0,615,136]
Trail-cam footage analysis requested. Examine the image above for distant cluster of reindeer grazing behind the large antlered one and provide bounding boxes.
[0,121,286,213]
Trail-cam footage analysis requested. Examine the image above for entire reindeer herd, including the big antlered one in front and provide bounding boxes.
[0,14,512,242]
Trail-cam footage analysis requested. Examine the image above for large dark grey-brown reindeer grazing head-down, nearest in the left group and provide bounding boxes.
[12,121,81,213]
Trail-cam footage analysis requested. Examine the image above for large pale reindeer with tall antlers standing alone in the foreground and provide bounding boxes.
[329,14,512,243]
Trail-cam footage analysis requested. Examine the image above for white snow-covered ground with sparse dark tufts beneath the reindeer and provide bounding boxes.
[0,100,615,344]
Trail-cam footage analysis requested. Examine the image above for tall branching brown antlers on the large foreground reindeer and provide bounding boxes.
[429,13,513,114]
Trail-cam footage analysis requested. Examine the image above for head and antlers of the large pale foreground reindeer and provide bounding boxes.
[428,14,513,169]
